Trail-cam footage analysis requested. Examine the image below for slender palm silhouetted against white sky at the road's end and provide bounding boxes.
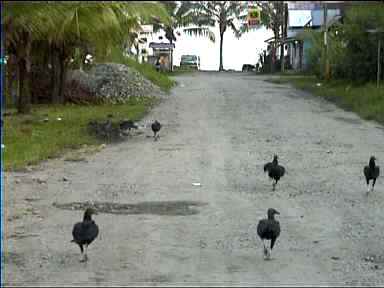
[184,1,247,71]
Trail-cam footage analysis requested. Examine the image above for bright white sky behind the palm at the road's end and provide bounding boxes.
[144,23,273,71]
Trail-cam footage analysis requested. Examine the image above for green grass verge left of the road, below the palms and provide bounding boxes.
[3,97,158,170]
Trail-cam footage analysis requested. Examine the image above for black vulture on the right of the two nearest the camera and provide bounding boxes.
[257,208,280,259]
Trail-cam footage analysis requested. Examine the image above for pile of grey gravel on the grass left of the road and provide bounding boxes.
[66,63,161,104]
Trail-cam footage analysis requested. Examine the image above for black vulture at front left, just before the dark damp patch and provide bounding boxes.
[71,208,99,262]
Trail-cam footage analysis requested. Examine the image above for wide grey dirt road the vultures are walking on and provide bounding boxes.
[3,72,384,286]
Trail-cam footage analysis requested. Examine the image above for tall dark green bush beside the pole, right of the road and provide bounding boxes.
[303,5,384,84]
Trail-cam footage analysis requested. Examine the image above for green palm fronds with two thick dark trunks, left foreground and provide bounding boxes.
[2,1,168,113]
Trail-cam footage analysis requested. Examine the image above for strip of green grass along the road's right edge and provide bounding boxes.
[267,76,384,124]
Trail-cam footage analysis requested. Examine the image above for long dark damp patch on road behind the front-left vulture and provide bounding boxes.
[53,201,207,216]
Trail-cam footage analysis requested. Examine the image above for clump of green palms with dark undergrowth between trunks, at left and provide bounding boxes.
[1,1,170,114]
